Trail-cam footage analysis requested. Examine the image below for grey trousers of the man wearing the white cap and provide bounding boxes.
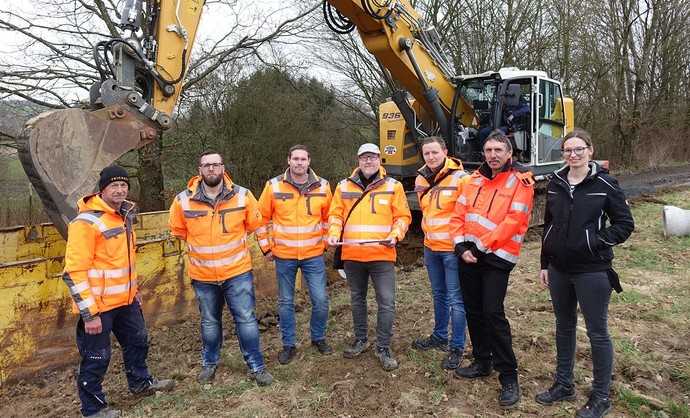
[343,261,395,347]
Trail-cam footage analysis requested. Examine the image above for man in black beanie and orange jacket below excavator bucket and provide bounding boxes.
[62,165,175,417]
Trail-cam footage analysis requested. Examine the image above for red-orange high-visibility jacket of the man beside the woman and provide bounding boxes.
[450,162,534,267]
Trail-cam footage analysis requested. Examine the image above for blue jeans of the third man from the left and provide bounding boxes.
[273,255,328,347]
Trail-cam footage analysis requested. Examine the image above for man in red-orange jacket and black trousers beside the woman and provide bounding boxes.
[450,130,534,408]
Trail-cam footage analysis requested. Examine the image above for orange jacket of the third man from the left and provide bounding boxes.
[256,169,332,260]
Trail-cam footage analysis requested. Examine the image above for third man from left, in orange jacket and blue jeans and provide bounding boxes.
[256,145,333,364]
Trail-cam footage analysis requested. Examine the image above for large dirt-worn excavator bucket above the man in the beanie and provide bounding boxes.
[17,105,159,237]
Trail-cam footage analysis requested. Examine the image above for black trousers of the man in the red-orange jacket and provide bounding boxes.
[460,259,518,384]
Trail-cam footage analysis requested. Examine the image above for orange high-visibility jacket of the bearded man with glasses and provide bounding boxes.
[169,173,261,282]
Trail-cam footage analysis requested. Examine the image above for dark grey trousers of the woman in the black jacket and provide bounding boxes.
[549,266,613,398]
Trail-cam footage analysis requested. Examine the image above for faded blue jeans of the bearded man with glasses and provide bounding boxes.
[192,271,264,372]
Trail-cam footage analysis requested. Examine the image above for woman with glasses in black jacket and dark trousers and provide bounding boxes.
[536,129,634,418]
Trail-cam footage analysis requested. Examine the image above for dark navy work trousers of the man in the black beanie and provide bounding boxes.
[77,300,151,416]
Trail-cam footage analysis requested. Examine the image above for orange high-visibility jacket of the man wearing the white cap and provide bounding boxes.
[328,167,412,262]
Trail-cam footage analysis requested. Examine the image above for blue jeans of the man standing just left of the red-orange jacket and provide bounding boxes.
[424,247,467,350]
